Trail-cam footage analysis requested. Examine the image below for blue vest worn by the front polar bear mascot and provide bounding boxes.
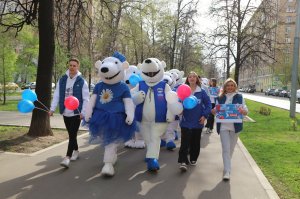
[135,81,167,122]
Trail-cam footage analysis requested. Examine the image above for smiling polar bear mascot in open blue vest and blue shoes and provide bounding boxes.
[132,58,182,171]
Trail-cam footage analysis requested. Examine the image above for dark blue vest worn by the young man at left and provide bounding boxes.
[59,75,84,114]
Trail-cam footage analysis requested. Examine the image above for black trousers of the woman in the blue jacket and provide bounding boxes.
[178,128,202,164]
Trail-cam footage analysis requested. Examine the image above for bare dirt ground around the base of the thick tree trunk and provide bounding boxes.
[0,127,85,154]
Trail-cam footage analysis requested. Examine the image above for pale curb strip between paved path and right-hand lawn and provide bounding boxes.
[237,139,280,199]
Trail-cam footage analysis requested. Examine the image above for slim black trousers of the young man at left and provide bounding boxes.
[64,115,81,157]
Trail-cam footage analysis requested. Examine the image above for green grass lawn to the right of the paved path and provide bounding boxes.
[240,100,300,199]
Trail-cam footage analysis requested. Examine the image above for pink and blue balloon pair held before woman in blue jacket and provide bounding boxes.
[177,84,198,109]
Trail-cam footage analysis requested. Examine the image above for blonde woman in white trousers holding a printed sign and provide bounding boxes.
[212,78,248,180]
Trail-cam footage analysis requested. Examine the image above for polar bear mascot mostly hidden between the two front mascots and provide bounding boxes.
[124,65,145,149]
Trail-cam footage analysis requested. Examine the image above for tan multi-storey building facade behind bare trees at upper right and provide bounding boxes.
[239,0,296,91]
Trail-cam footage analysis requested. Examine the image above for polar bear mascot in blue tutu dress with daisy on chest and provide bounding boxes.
[85,52,136,176]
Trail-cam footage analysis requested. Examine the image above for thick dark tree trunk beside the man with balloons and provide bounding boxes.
[28,0,55,136]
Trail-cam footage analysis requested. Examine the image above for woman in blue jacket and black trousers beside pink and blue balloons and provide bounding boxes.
[178,71,211,171]
